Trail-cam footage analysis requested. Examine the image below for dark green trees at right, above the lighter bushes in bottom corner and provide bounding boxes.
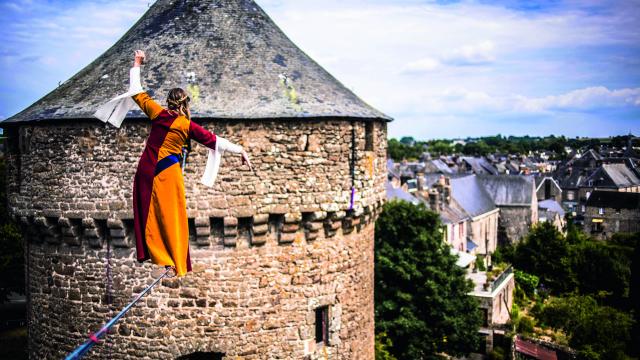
[510,223,636,308]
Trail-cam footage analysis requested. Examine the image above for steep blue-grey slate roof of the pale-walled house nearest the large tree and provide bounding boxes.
[451,175,496,217]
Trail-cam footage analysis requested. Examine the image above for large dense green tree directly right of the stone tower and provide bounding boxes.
[375,201,481,359]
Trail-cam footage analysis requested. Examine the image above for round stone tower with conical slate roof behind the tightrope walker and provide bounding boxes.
[0,0,390,359]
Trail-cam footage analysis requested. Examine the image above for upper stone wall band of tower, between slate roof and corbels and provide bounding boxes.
[7,120,386,219]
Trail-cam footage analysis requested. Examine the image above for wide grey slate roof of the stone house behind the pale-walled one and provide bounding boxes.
[478,175,534,206]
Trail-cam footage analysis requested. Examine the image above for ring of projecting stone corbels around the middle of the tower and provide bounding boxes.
[19,203,382,249]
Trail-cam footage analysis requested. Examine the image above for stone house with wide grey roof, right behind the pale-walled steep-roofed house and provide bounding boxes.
[477,175,538,244]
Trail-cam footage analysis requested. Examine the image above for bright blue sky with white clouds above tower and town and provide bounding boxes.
[0,0,640,139]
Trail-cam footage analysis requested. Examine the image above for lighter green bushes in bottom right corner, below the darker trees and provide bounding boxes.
[540,295,632,359]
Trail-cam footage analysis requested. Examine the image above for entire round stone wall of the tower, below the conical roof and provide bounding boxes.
[7,116,386,359]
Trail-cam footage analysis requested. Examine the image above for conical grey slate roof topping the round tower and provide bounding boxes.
[3,0,391,125]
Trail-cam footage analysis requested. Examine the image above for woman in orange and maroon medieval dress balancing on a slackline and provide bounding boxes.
[125,50,251,276]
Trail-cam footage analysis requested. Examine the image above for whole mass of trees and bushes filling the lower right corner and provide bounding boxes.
[508,221,638,359]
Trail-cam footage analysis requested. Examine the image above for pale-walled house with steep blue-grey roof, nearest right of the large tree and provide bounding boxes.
[450,175,500,261]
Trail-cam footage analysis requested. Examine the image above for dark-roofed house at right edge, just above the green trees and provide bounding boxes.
[584,190,640,239]
